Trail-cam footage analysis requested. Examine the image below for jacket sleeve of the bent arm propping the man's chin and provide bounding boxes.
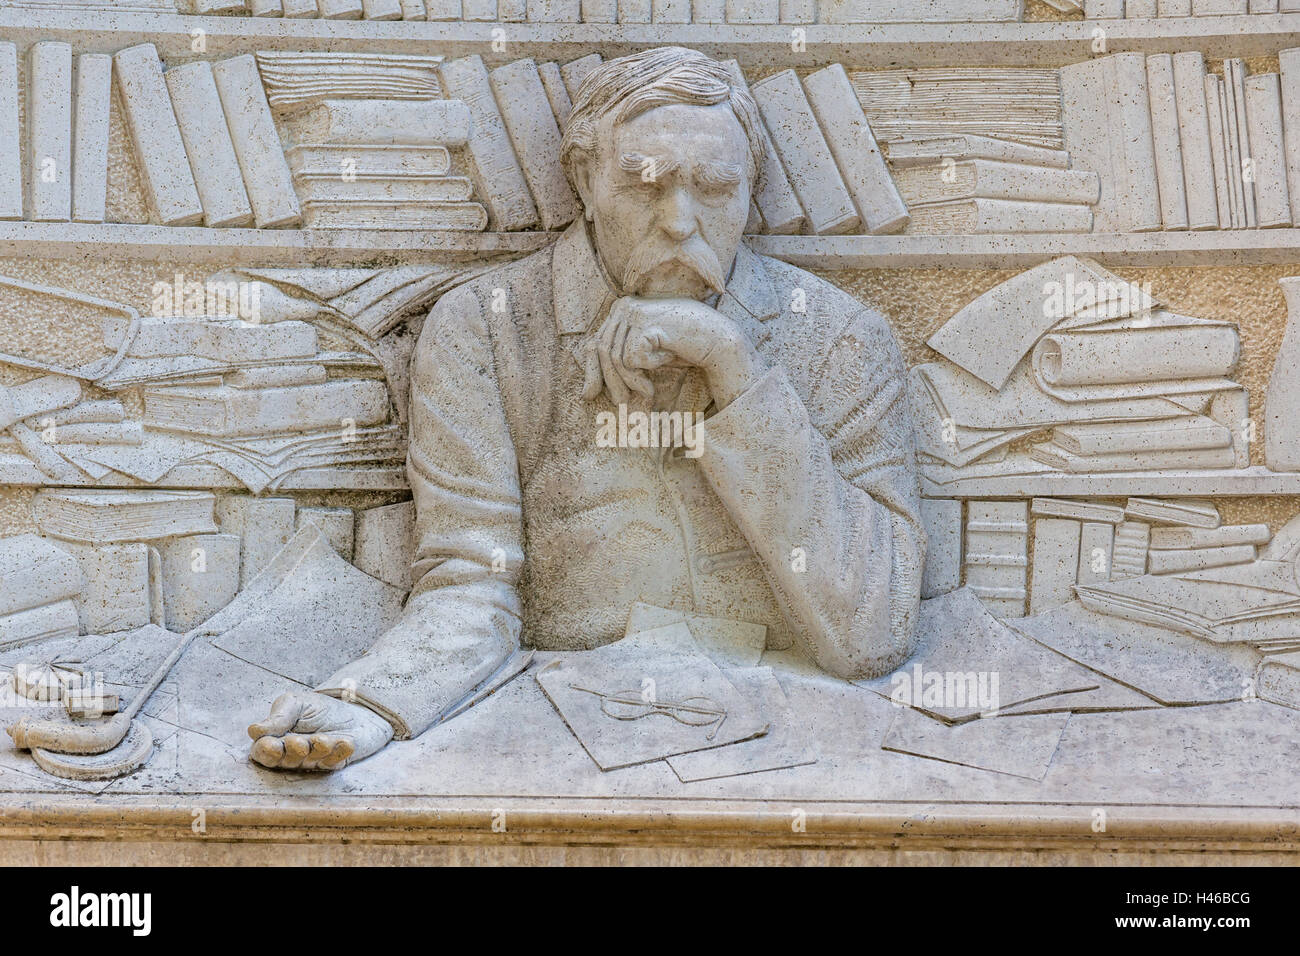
[699,311,926,679]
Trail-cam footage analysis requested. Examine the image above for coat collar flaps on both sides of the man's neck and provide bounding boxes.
[551,217,779,336]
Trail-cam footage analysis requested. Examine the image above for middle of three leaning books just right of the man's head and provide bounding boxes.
[753,70,862,234]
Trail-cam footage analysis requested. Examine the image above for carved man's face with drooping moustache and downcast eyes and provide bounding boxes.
[577,103,750,300]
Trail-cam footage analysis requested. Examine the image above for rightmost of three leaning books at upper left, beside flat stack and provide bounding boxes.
[212,53,303,229]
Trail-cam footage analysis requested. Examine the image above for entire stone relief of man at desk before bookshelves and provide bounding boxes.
[0,0,1300,868]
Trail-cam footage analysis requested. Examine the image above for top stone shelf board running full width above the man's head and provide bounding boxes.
[0,8,1300,69]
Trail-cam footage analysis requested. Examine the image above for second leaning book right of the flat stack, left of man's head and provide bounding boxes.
[488,60,580,229]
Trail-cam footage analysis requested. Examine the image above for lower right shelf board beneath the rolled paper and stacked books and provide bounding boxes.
[920,464,1300,498]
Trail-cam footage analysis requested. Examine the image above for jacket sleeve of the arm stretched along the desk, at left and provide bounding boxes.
[317,286,524,739]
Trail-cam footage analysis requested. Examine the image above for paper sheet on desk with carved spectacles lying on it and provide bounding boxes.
[537,623,767,770]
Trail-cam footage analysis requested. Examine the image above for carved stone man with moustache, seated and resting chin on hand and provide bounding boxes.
[250,48,924,770]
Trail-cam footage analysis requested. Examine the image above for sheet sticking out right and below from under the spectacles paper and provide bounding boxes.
[668,667,818,783]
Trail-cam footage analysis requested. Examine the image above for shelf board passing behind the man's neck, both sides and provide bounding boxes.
[17,222,1300,269]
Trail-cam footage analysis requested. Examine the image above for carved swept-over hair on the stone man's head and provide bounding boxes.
[560,47,763,195]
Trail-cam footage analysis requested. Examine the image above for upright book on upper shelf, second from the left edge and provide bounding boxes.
[27,40,73,222]
